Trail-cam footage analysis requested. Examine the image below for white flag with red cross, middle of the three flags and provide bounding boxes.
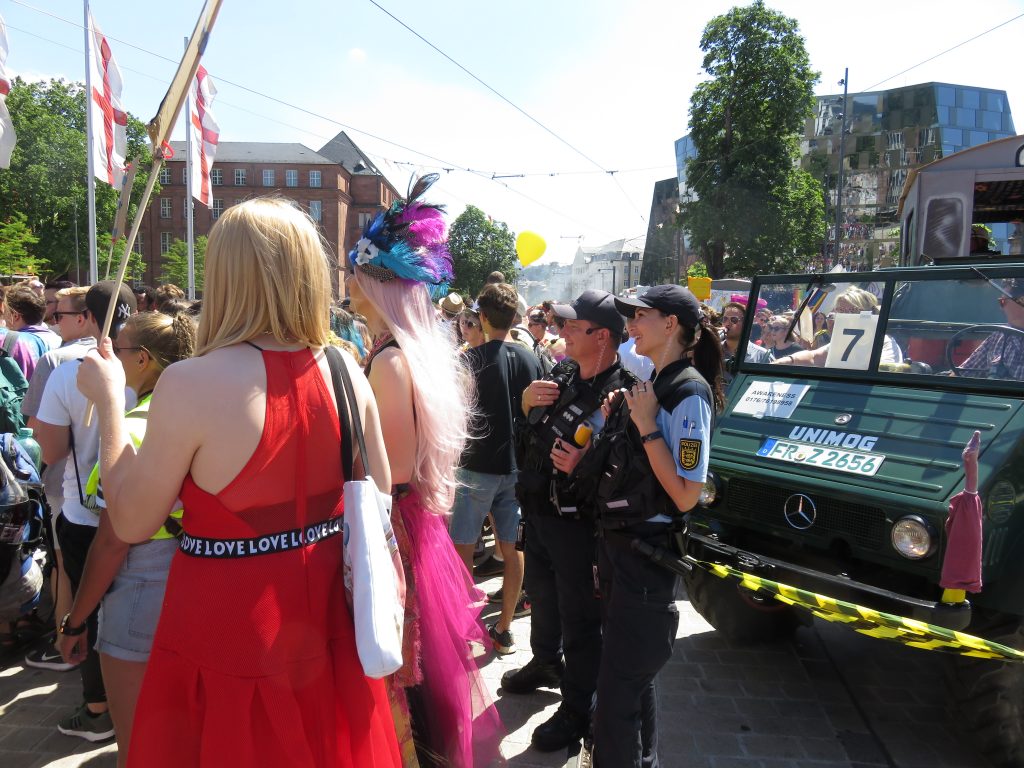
[88,11,128,188]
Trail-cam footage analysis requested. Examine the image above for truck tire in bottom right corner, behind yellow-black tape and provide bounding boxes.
[946,615,1024,768]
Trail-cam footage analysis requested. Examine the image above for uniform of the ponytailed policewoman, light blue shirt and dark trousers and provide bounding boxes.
[593,290,714,768]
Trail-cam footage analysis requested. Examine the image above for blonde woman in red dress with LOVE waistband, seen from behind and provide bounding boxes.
[79,199,400,768]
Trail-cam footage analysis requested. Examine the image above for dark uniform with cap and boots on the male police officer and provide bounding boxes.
[502,291,636,751]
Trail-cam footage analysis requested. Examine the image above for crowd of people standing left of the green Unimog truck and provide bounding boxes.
[4,178,723,768]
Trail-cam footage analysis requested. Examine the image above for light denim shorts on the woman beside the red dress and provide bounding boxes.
[96,539,178,662]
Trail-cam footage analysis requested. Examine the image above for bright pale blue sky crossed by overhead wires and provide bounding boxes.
[0,0,1024,261]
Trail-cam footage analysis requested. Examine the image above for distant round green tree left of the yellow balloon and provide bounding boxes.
[449,206,516,297]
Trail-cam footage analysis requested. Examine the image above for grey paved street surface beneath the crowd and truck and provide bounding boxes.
[0,579,986,768]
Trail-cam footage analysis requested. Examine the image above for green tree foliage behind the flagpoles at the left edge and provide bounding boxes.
[0,78,159,280]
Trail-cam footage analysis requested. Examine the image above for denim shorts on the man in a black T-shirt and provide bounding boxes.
[449,468,520,544]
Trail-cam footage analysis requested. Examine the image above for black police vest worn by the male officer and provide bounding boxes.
[516,360,637,509]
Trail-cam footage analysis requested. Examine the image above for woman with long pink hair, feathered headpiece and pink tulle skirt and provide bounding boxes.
[348,174,501,768]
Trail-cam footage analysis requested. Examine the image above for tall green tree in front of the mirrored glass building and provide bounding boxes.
[682,0,825,278]
